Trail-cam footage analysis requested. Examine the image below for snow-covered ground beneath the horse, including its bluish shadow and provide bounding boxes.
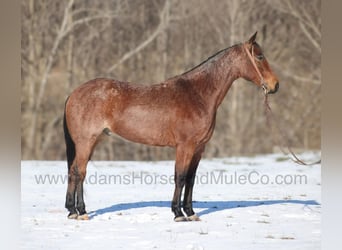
[21,153,321,250]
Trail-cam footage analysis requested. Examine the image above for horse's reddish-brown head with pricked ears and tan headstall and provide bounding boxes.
[242,32,279,94]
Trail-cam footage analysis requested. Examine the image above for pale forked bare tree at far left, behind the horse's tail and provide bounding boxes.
[22,0,123,157]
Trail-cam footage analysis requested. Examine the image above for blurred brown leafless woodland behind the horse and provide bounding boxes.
[21,0,322,160]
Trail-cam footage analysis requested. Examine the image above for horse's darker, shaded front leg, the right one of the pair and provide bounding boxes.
[183,146,204,221]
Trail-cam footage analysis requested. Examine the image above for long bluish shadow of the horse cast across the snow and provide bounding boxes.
[89,200,320,219]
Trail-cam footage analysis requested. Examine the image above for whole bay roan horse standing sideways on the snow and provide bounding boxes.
[64,33,279,221]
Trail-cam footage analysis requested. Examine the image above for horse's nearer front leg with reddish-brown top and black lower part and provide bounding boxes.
[171,145,194,221]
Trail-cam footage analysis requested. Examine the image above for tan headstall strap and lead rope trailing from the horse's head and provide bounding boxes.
[243,44,321,166]
